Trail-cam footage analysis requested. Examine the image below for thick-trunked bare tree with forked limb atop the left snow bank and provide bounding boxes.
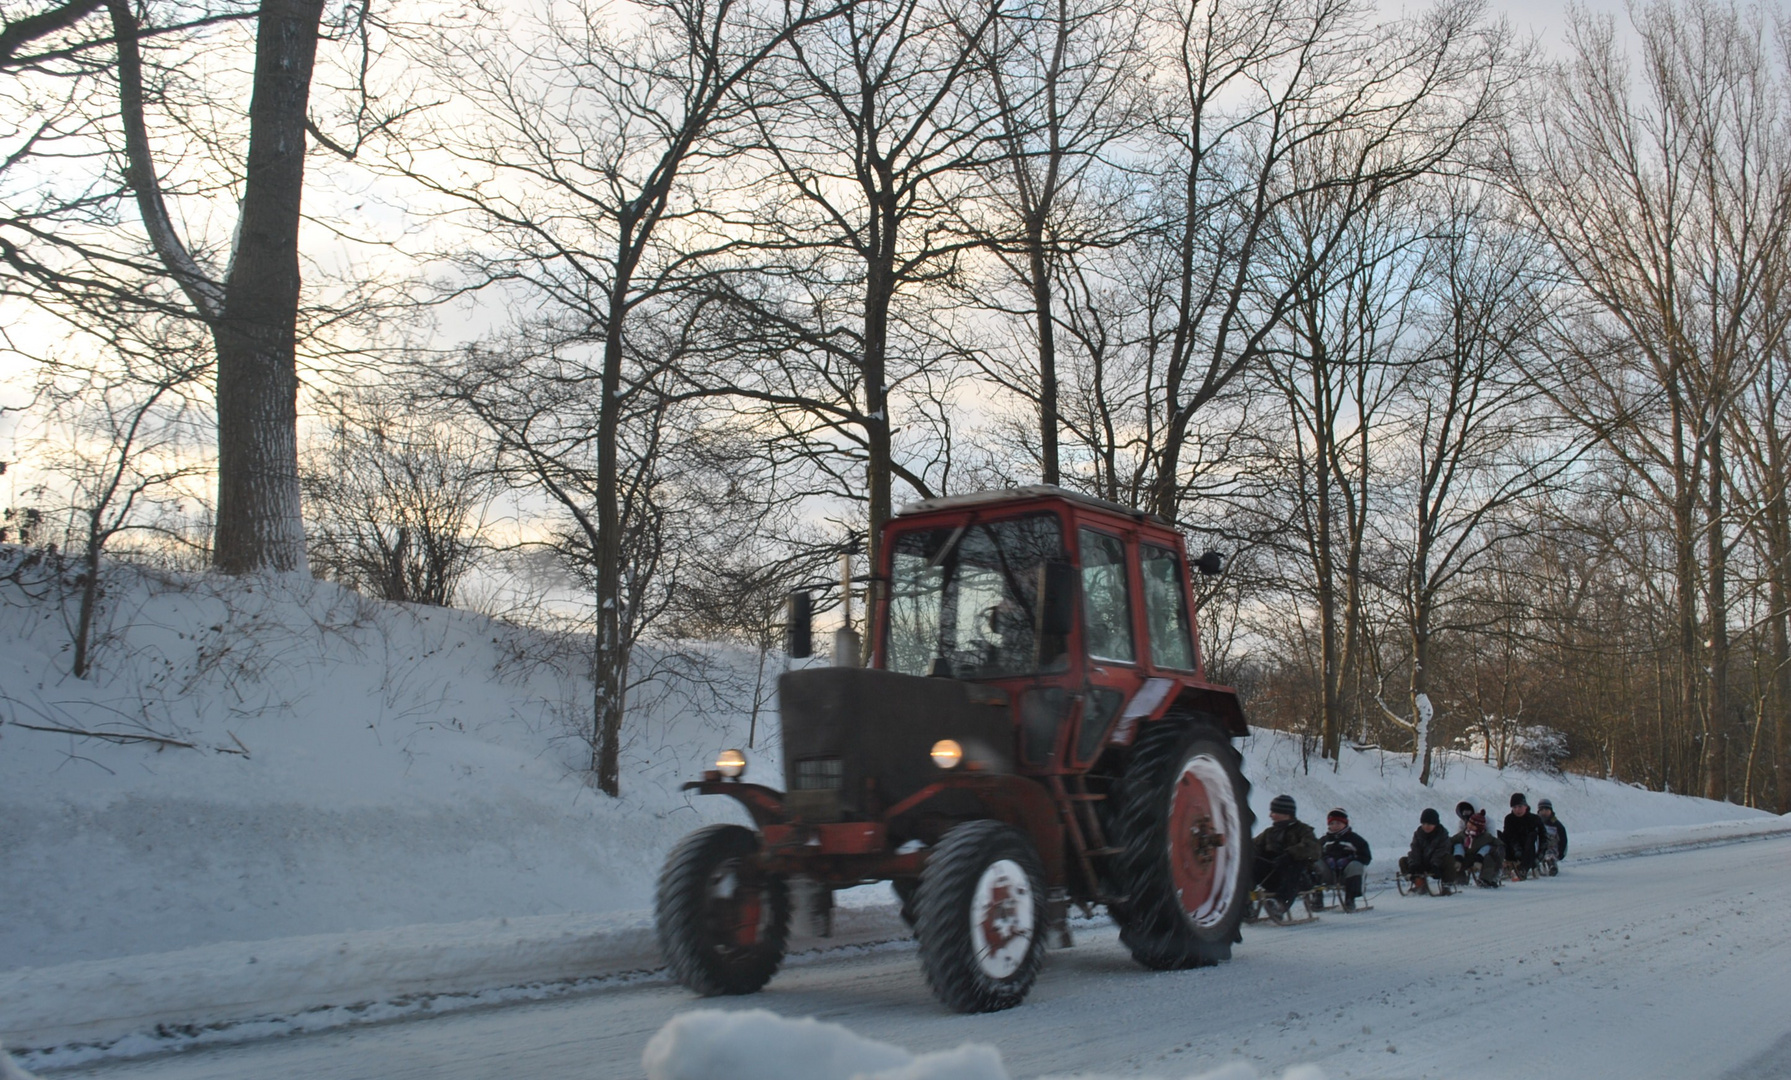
[0,0,406,573]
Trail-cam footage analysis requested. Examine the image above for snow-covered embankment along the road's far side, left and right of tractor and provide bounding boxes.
[0,548,1791,1064]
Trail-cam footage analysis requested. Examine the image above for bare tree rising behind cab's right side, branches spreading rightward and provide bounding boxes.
[1148,0,1517,518]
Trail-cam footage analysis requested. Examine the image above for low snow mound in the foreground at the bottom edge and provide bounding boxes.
[641,1008,1324,1080]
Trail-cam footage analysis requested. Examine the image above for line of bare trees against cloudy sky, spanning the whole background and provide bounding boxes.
[0,0,1791,811]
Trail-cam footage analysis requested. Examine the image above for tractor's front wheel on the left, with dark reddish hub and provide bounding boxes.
[654,826,790,998]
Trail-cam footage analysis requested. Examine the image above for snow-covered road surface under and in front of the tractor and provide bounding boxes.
[42,838,1791,1080]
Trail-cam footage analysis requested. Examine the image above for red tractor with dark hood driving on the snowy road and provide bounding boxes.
[656,487,1254,1012]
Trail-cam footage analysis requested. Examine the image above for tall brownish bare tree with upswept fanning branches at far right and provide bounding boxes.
[1512,0,1791,799]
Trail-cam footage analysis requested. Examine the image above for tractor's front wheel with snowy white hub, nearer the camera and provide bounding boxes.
[913,820,1046,1012]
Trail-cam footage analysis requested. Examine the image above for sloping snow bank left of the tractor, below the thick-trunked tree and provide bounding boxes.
[0,548,779,971]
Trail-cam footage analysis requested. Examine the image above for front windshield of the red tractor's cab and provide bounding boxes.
[885,514,1066,679]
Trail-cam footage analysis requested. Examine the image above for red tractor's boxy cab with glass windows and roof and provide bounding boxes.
[872,485,1245,774]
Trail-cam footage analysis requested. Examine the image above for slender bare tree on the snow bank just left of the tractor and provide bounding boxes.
[399,0,835,795]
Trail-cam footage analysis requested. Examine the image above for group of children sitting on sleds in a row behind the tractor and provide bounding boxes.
[1255,792,1567,922]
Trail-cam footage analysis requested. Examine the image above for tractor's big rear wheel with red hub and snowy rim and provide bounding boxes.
[1112,716,1255,971]
